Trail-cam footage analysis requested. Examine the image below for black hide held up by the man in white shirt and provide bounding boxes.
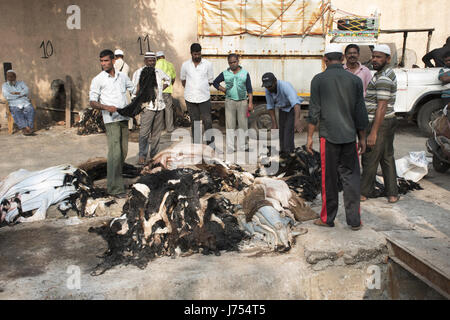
[117,67,158,117]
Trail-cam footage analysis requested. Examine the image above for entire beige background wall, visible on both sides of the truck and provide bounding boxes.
[0,0,450,116]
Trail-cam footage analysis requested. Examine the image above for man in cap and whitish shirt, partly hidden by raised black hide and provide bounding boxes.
[133,52,171,165]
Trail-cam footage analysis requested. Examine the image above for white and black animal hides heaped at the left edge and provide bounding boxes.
[0,158,140,226]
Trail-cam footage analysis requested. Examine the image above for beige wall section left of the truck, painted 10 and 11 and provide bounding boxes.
[0,0,197,109]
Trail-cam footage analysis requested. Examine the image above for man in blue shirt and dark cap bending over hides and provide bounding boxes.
[262,72,303,154]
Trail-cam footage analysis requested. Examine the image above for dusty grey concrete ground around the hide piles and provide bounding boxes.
[0,121,450,299]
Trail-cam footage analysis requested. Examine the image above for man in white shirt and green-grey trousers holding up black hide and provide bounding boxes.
[89,49,134,198]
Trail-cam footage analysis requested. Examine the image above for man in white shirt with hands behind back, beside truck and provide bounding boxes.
[180,43,214,144]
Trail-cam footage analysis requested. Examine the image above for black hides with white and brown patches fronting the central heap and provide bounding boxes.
[89,166,250,275]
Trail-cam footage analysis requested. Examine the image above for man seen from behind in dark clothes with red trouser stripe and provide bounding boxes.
[306,44,368,230]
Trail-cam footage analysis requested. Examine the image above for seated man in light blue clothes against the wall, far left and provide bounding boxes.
[2,70,34,136]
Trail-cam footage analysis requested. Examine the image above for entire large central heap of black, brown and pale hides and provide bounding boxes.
[89,143,317,275]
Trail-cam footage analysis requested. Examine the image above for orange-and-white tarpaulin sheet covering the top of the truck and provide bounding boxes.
[197,0,332,36]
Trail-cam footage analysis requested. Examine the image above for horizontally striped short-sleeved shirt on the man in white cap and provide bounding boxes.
[365,65,397,120]
